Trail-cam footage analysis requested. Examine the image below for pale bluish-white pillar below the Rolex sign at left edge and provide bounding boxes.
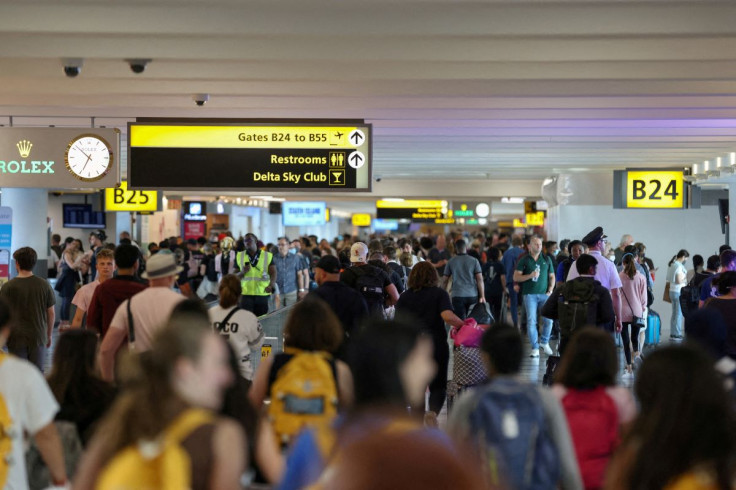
[0,187,49,278]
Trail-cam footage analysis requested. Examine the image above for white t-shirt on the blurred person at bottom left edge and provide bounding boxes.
[0,354,59,490]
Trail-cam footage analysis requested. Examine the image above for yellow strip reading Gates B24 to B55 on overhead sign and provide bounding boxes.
[130,125,366,149]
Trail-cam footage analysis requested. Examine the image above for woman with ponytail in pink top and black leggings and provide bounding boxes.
[619,251,647,376]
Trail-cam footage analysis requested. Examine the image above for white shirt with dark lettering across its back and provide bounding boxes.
[209,305,263,380]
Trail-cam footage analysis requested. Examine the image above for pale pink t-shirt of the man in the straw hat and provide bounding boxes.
[110,287,186,352]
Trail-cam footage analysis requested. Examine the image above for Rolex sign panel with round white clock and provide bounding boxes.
[0,128,120,189]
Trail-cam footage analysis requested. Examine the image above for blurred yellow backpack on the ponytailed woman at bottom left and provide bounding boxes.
[95,409,214,490]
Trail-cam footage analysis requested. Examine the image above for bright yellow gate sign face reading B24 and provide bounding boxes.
[626,170,685,209]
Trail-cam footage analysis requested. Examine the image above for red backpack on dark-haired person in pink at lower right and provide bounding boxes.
[562,386,619,488]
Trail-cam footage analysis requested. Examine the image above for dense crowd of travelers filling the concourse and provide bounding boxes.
[0,227,736,490]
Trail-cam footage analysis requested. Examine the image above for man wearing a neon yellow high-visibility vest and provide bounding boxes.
[235,233,276,316]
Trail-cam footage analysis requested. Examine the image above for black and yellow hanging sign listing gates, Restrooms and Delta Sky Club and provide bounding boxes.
[128,121,372,192]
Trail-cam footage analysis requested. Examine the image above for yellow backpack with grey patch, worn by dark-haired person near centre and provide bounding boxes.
[268,348,338,445]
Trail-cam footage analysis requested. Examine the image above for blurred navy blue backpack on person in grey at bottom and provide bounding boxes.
[470,378,560,490]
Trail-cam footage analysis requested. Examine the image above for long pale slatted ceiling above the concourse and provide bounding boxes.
[0,0,736,187]
